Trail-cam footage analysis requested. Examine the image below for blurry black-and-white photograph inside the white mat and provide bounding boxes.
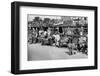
[27,14,88,61]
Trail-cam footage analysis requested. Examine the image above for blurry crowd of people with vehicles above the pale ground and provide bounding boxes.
[28,27,88,55]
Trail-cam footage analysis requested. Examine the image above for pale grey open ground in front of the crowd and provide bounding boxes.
[28,44,88,61]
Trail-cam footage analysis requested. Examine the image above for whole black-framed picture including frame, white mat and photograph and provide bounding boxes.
[11,2,97,74]
